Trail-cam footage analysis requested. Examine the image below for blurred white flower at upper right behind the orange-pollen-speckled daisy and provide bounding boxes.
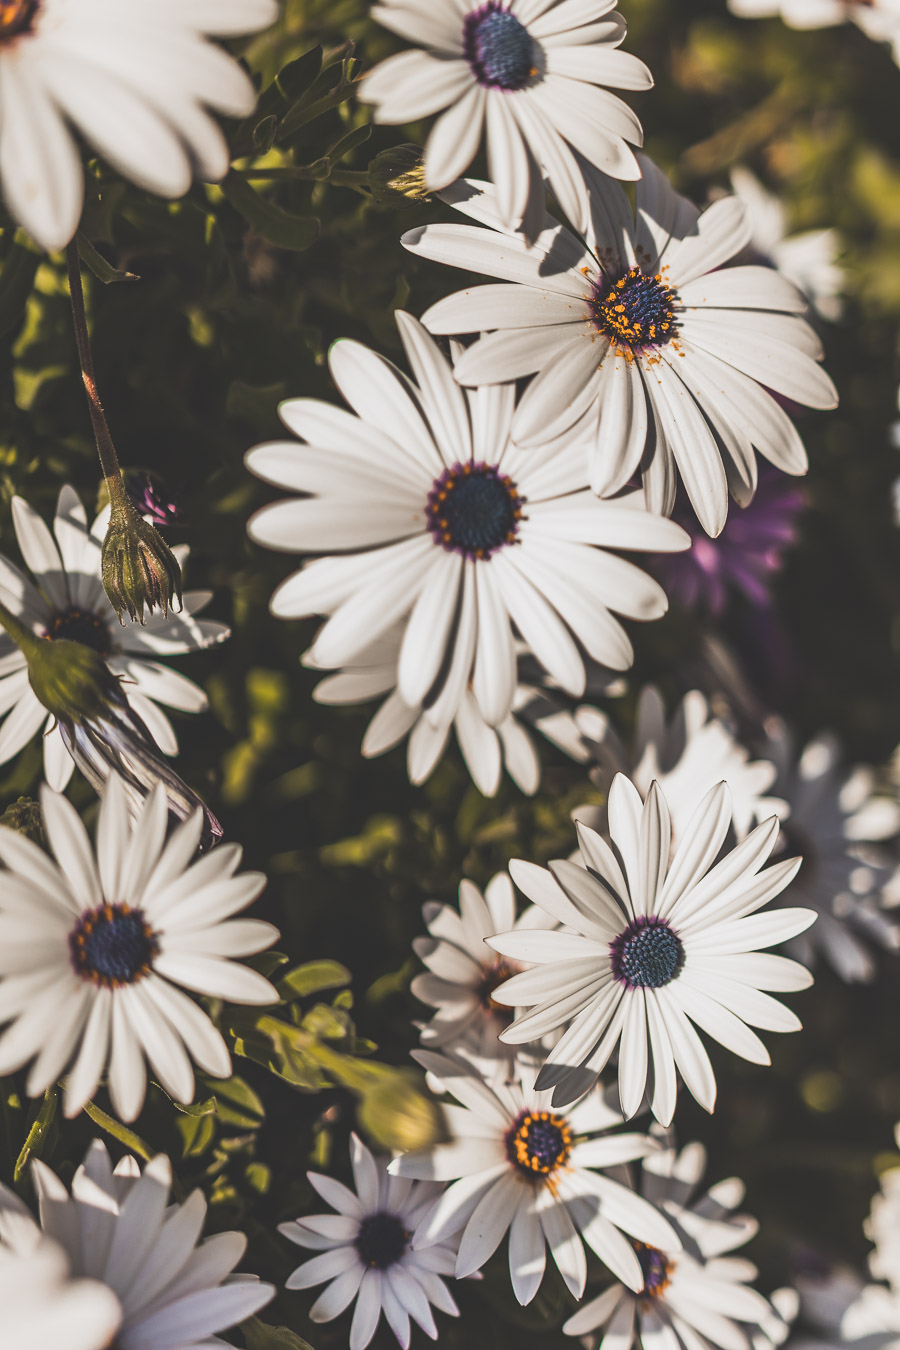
[731,165,843,323]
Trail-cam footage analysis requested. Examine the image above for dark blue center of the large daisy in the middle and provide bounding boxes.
[425,462,525,559]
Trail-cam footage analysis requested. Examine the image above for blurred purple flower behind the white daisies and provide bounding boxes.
[656,464,807,616]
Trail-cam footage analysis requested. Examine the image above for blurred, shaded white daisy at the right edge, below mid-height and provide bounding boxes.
[762,718,900,981]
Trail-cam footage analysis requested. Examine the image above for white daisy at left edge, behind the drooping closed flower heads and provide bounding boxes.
[0,486,229,792]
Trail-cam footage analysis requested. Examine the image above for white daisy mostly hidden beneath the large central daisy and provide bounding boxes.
[310,628,587,797]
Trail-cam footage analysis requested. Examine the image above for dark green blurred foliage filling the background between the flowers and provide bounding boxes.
[0,0,900,1350]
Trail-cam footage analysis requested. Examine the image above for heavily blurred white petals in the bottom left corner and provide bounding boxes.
[0,1185,121,1350]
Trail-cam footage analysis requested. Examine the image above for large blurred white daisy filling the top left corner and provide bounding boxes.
[0,0,278,250]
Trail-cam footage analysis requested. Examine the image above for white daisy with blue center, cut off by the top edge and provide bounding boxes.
[360,0,653,234]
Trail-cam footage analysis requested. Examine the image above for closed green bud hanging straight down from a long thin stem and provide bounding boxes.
[101,479,181,624]
